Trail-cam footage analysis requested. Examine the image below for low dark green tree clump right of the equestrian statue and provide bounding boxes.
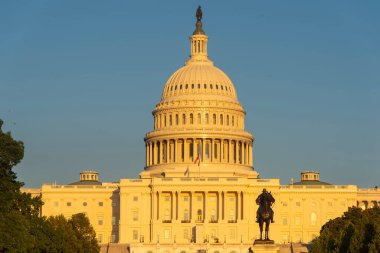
[311,207,380,253]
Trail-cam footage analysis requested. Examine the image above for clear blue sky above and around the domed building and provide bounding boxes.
[0,0,380,187]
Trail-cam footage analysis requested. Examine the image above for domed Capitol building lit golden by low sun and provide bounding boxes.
[24,6,380,253]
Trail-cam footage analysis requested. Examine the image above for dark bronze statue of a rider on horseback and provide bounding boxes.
[256,189,275,241]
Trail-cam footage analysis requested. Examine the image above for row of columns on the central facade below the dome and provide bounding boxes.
[152,191,245,222]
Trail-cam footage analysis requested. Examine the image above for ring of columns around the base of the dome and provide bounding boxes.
[145,138,252,166]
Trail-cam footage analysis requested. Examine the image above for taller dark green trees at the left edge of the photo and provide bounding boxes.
[0,119,100,253]
